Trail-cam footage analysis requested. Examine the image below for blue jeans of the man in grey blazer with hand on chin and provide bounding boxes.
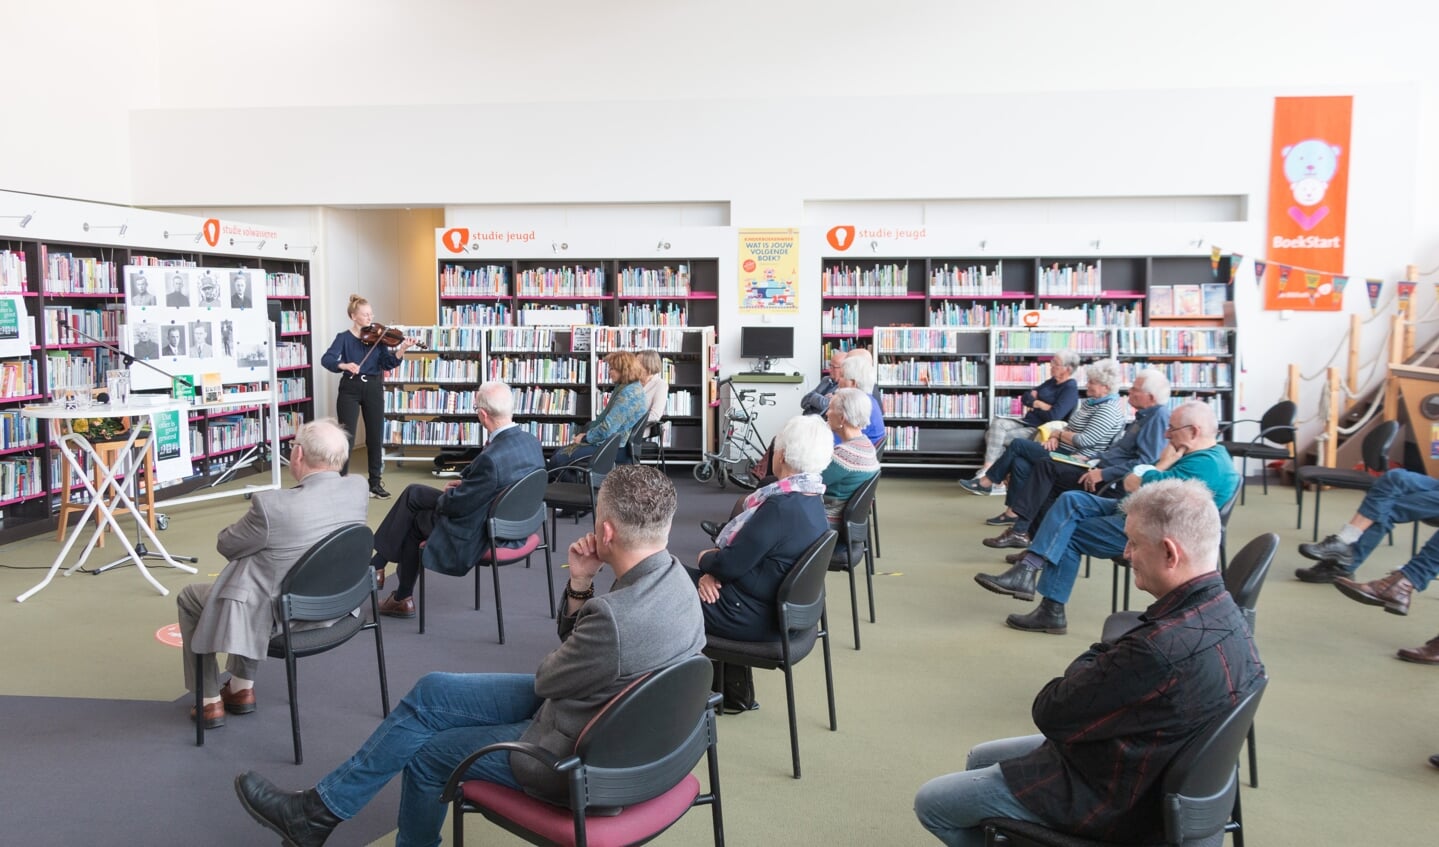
[315,673,544,847]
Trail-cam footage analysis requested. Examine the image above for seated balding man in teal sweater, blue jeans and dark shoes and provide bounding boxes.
[974,400,1239,636]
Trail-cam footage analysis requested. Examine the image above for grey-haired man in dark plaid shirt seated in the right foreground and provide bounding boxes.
[914,480,1265,847]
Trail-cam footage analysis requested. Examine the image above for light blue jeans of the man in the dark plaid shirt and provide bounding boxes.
[914,735,1045,847]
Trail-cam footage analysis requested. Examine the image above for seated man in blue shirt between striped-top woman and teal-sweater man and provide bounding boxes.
[984,368,1168,548]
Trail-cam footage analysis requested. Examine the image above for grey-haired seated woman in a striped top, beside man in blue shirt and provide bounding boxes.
[960,360,1124,503]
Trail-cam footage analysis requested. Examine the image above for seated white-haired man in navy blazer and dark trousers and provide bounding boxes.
[370,381,544,617]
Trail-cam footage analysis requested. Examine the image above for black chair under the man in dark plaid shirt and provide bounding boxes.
[983,682,1265,847]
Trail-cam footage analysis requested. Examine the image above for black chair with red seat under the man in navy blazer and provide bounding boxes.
[414,469,554,644]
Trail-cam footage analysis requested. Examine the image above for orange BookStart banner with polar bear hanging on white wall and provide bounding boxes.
[1263,96,1354,312]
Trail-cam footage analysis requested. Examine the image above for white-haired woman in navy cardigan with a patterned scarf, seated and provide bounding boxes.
[691,414,834,712]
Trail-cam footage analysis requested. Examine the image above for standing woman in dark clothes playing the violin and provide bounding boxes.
[319,295,414,499]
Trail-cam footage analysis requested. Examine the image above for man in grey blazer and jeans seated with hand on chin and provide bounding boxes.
[235,464,705,846]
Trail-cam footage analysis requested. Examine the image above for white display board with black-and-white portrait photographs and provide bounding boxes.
[121,266,272,390]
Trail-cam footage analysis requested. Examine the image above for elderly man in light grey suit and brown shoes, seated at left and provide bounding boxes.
[176,418,370,729]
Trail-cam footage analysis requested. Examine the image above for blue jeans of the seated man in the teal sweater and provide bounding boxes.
[1029,492,1128,603]
